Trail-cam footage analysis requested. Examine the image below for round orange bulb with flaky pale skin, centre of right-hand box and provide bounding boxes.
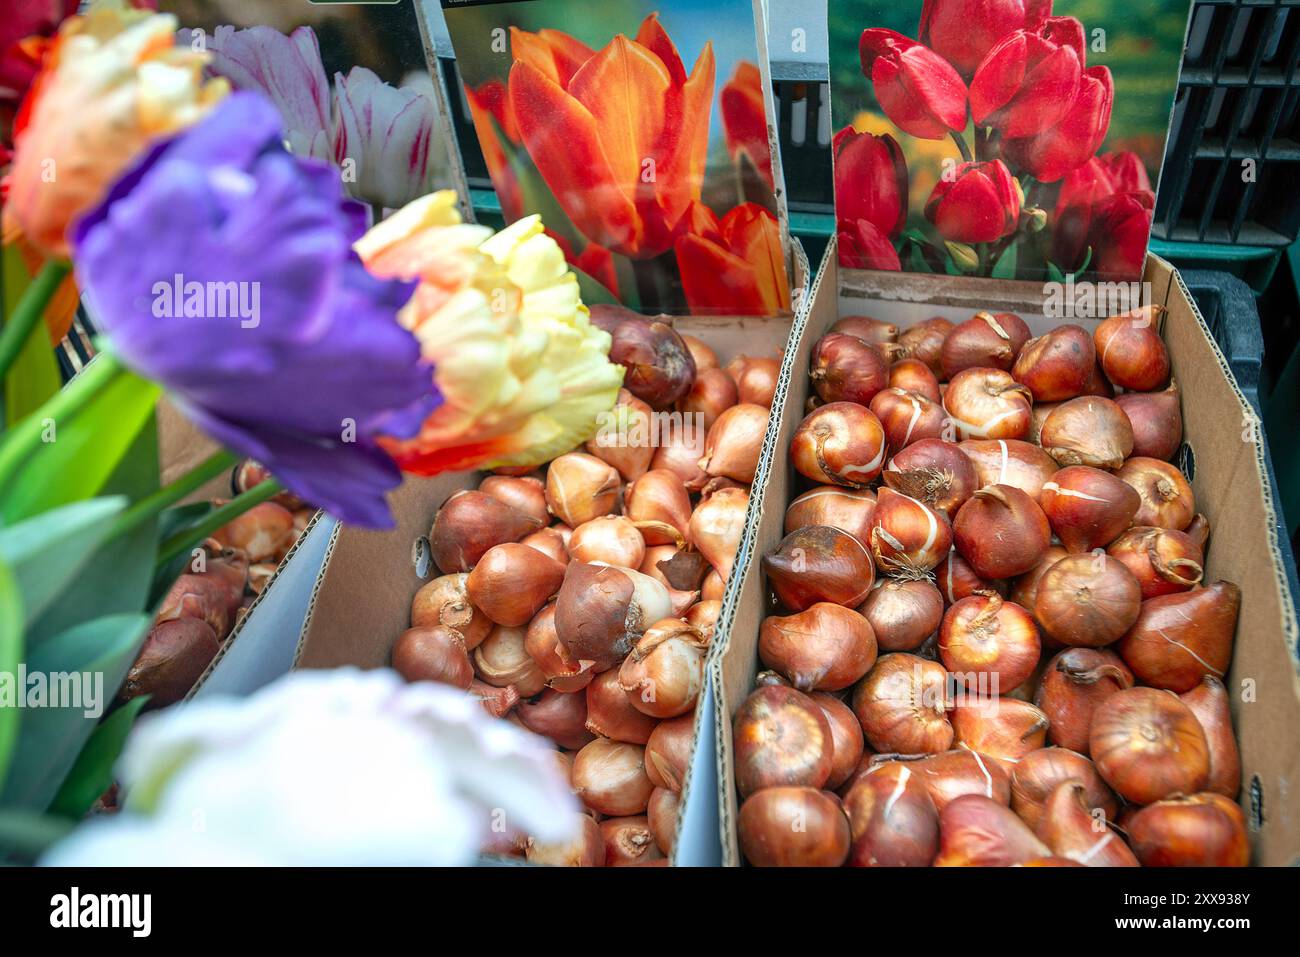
[939,592,1041,694]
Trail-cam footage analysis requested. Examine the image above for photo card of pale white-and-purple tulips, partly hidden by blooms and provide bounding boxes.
[157,0,469,217]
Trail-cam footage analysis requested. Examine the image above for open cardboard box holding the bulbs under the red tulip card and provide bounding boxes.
[683,241,1300,866]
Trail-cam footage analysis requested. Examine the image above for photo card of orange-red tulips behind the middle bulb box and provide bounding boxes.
[443,0,790,316]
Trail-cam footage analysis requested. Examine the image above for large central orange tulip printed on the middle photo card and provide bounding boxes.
[508,13,714,259]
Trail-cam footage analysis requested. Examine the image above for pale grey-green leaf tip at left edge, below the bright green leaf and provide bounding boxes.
[0,495,126,623]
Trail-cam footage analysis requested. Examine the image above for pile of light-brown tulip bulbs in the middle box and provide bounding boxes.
[393,307,779,866]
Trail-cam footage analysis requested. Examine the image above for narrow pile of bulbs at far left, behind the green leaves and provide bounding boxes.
[118,459,316,709]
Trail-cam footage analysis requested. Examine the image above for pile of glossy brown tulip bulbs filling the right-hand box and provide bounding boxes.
[735,307,1249,867]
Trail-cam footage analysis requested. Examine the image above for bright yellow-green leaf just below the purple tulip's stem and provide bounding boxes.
[0,356,160,523]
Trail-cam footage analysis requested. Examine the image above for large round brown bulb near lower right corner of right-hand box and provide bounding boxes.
[1088,688,1210,804]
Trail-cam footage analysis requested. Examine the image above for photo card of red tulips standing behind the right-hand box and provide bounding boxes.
[829,0,1188,282]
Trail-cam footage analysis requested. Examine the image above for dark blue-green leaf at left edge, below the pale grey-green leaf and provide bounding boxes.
[0,612,152,811]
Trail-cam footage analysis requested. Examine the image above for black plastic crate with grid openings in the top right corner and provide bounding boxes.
[1152,0,1300,246]
